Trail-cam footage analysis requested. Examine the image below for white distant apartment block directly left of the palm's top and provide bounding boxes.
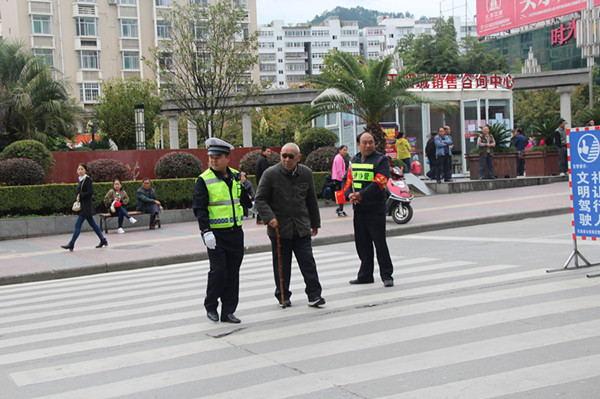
[258,18,360,88]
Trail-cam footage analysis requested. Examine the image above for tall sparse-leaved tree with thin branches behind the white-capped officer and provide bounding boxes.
[150,0,258,144]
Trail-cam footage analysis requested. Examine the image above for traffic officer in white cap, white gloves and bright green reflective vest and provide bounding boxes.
[192,138,252,323]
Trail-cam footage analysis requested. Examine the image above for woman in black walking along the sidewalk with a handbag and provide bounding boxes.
[61,164,108,251]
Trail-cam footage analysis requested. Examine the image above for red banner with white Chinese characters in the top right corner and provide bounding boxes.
[477,0,600,36]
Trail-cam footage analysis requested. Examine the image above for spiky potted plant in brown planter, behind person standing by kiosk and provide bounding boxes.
[466,123,517,180]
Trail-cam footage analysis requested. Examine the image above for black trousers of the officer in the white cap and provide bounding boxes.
[204,228,244,315]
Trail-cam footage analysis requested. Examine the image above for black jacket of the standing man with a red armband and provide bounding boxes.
[345,152,390,214]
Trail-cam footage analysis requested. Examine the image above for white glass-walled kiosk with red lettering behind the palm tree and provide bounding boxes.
[314,75,514,177]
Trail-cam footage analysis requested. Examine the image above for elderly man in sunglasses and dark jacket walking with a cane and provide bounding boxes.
[255,143,325,307]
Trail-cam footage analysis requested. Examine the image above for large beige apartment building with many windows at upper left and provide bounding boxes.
[0,0,258,106]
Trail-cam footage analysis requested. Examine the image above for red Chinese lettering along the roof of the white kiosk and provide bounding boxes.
[396,73,514,90]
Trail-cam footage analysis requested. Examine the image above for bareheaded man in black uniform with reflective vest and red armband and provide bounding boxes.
[340,132,394,287]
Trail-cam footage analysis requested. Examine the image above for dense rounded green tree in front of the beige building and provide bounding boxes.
[96,79,162,149]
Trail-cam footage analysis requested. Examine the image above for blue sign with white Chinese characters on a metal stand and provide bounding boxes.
[567,126,600,238]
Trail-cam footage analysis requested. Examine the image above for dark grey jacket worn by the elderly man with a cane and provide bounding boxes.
[255,163,321,239]
